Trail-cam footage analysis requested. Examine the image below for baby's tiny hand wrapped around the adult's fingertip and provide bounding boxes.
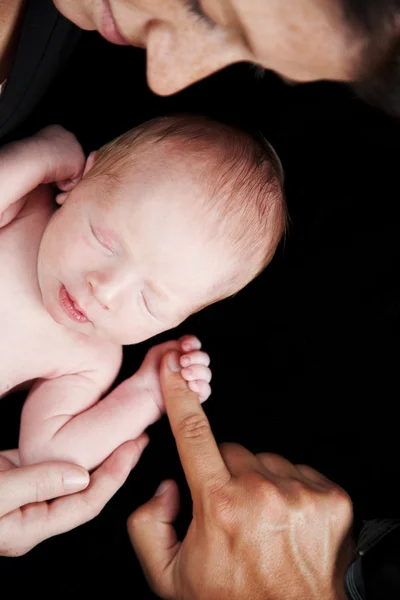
[137,335,211,412]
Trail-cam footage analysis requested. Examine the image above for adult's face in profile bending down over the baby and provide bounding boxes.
[54,0,364,95]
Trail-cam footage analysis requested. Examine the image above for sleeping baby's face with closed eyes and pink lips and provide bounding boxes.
[38,164,236,344]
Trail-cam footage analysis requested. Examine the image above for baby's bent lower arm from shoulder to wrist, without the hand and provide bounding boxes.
[19,344,152,469]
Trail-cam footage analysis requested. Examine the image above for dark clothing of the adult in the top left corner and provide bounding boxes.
[0,0,80,143]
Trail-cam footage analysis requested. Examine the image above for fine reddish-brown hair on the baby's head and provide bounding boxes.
[88,114,288,288]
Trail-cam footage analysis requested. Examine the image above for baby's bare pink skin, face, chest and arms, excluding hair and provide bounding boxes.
[0,126,264,470]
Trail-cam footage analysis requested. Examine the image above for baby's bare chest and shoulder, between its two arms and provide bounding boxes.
[0,186,114,396]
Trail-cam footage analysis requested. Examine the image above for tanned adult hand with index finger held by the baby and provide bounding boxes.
[128,352,352,600]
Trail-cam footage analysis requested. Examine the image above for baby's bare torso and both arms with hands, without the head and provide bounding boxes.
[0,128,211,469]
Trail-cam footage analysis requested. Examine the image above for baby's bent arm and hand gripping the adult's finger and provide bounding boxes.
[19,336,211,469]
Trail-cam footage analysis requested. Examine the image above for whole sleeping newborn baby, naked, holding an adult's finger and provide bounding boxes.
[0,116,286,469]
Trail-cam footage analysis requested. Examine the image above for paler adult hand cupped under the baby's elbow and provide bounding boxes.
[0,435,148,556]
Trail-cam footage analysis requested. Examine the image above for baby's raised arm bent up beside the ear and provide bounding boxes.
[0,125,85,227]
